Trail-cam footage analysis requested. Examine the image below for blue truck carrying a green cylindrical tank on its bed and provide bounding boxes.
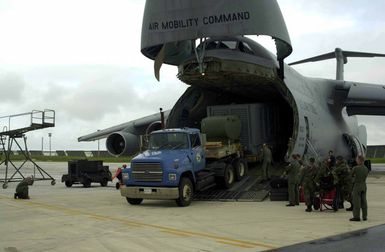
[120,115,248,207]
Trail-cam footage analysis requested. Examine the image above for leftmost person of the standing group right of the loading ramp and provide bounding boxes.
[284,154,301,206]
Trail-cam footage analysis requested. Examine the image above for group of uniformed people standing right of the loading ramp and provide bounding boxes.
[284,151,369,221]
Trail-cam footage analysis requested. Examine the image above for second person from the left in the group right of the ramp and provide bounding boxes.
[300,158,318,212]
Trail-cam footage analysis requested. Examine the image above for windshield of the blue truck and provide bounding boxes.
[148,132,188,150]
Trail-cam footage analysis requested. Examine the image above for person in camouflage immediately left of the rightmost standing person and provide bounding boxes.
[332,156,353,211]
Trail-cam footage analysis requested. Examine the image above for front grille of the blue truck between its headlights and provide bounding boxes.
[132,163,163,182]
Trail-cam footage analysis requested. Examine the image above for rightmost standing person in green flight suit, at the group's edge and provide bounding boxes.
[350,155,369,221]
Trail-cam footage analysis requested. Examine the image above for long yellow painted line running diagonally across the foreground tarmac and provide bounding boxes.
[0,195,277,249]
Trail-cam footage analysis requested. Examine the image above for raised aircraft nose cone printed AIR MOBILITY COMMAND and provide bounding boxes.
[141,0,292,66]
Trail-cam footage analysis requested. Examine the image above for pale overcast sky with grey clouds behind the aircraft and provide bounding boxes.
[0,0,385,150]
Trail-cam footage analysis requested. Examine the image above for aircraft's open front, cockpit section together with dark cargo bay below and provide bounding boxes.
[167,36,298,161]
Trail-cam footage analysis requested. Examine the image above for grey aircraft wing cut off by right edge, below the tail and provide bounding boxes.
[336,81,385,116]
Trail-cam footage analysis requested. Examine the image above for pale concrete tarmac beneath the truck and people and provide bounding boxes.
[0,163,385,252]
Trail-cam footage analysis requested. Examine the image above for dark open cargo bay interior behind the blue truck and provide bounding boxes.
[167,87,294,161]
